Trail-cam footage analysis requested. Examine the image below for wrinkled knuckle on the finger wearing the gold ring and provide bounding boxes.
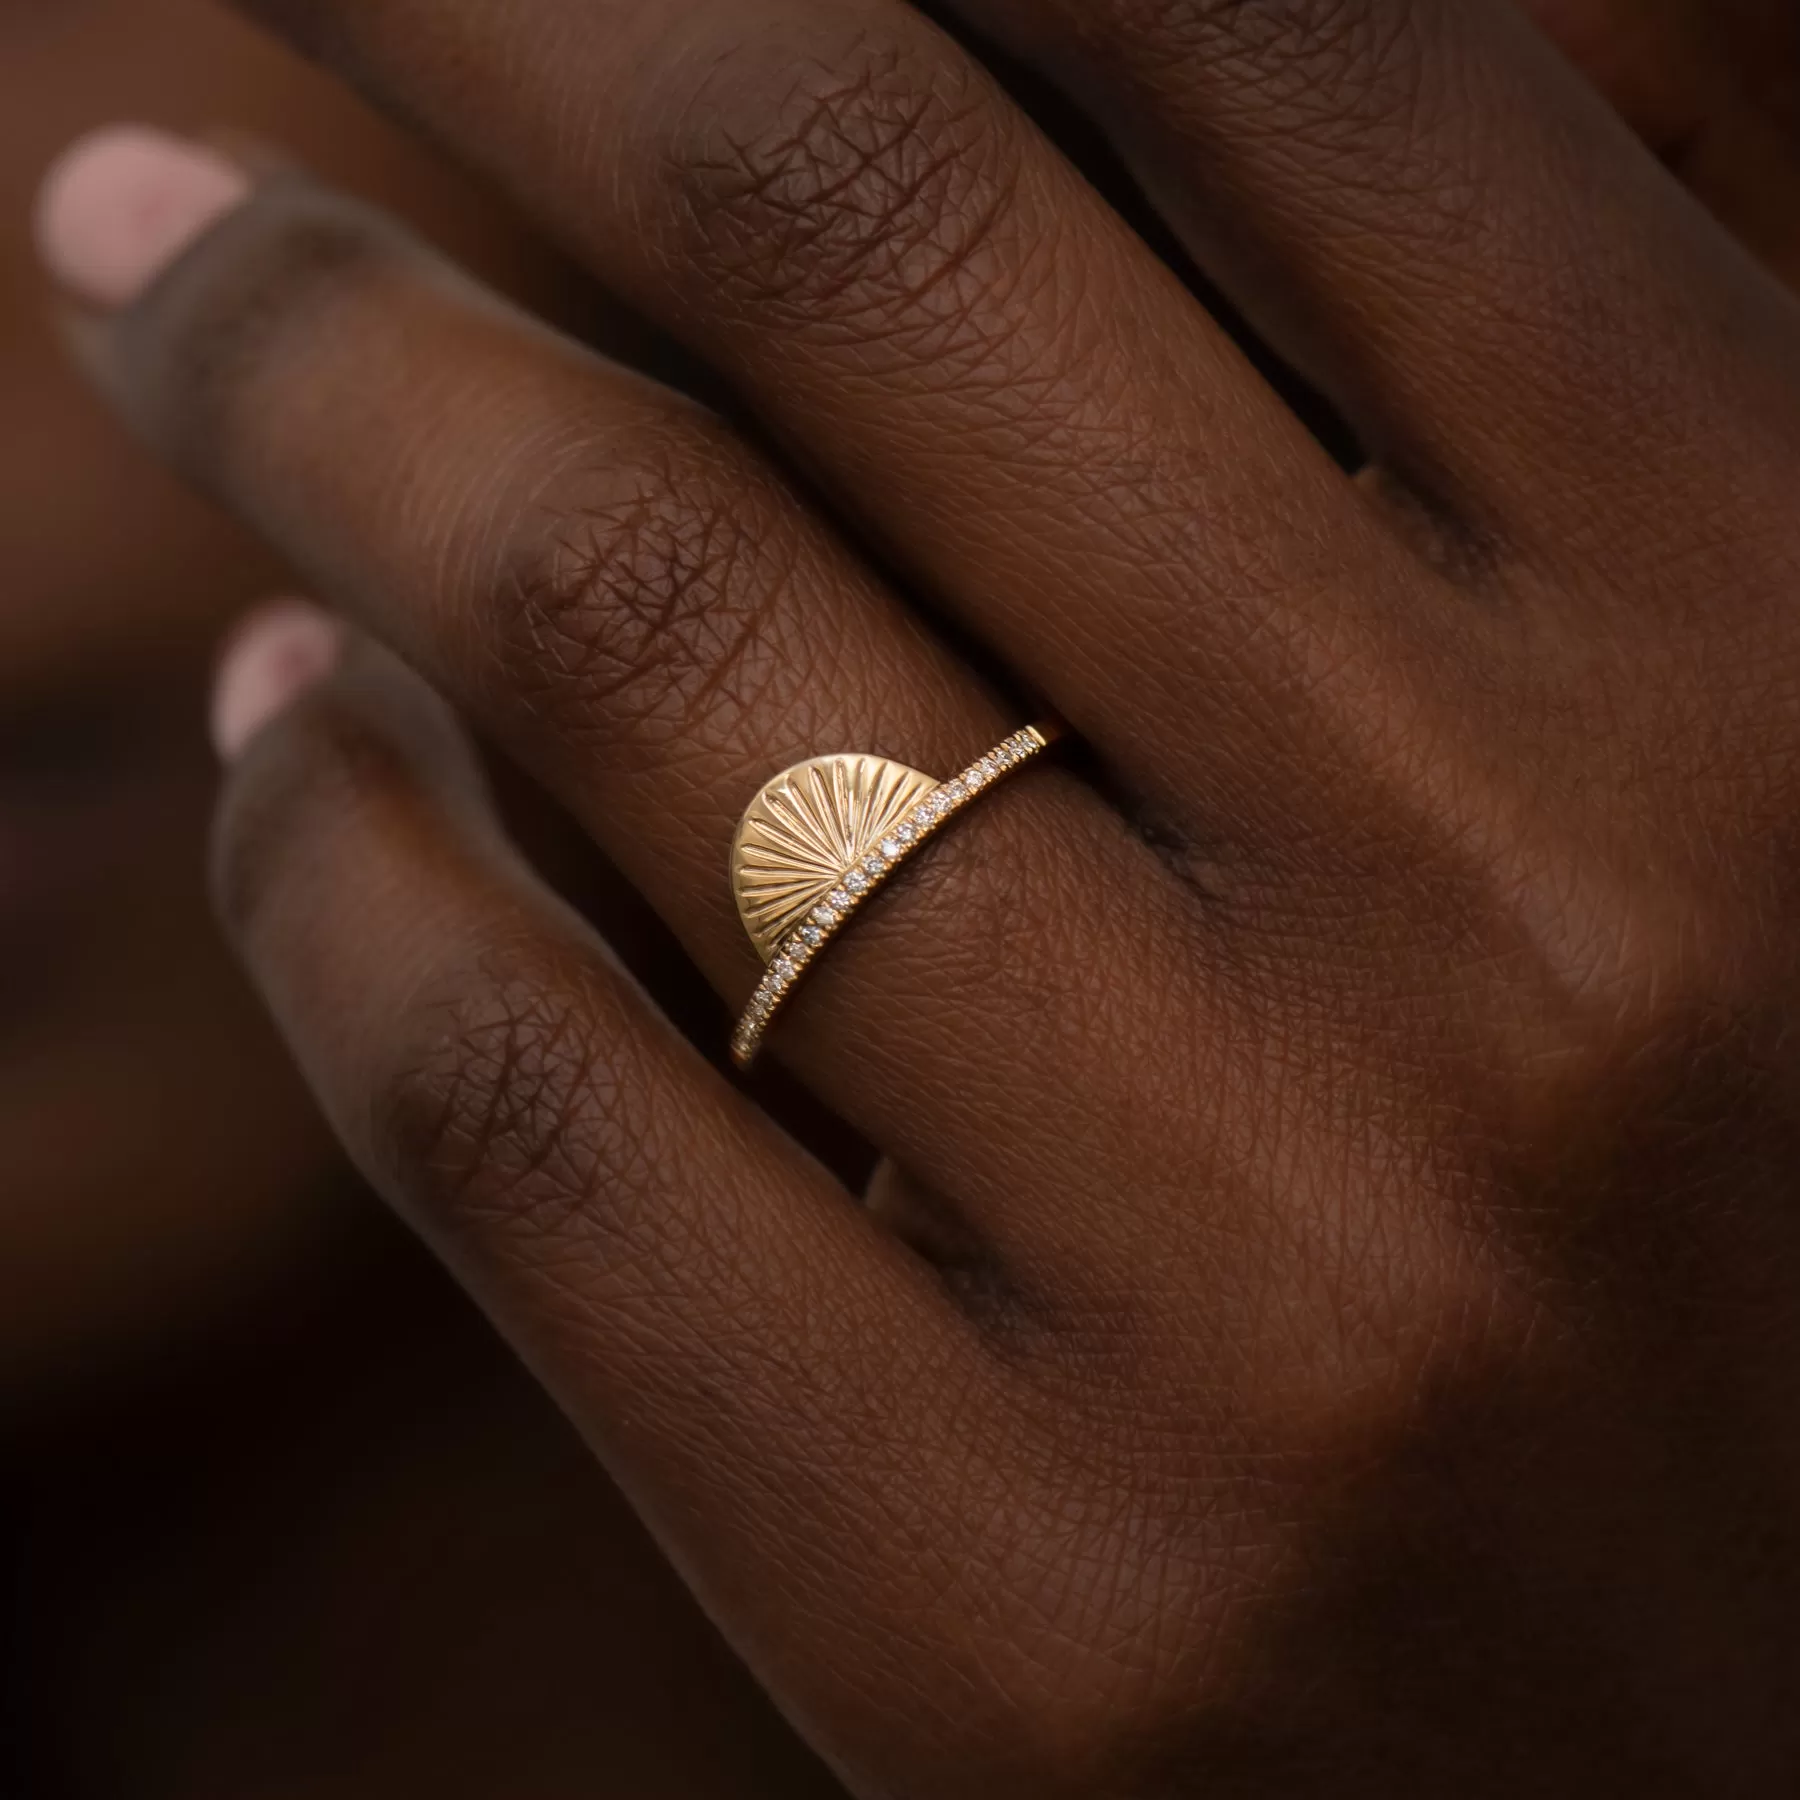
[493,428,799,742]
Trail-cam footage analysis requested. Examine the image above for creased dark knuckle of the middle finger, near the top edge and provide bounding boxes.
[659,25,1017,340]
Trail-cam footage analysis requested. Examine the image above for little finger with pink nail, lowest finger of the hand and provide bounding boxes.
[206,608,1044,1771]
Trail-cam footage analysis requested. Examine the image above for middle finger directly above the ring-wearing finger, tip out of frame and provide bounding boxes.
[217,0,1425,828]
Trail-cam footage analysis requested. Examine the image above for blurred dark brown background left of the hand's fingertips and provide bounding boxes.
[0,0,828,1800]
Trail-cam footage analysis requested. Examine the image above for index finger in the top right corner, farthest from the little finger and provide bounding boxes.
[961,0,1791,545]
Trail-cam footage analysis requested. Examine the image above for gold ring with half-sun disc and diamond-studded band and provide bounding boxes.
[731,724,1062,1069]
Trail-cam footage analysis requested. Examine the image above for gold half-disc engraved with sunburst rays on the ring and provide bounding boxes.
[731,756,938,963]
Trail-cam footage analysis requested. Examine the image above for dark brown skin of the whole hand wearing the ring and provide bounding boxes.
[42,0,1800,1800]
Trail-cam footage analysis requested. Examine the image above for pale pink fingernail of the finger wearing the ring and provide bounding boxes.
[36,124,250,310]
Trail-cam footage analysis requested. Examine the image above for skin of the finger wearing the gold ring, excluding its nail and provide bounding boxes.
[38,130,1193,1310]
